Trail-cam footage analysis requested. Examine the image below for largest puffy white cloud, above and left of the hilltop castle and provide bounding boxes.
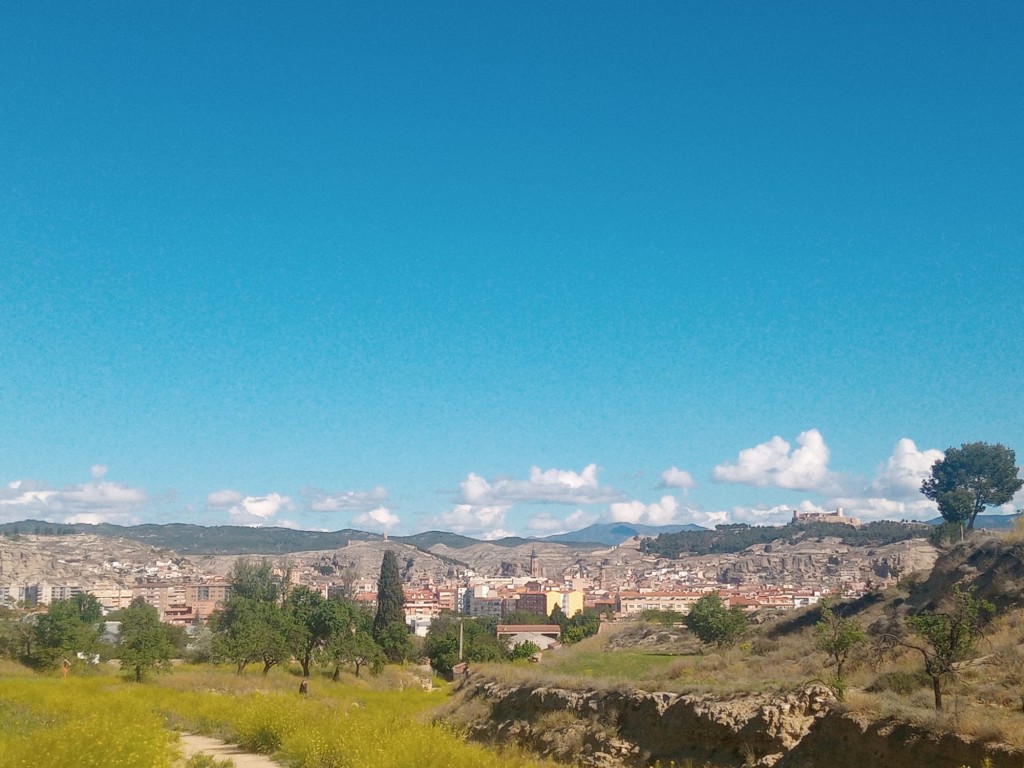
[712,429,831,490]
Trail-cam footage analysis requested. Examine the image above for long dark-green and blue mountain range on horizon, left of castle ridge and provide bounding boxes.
[0,520,702,555]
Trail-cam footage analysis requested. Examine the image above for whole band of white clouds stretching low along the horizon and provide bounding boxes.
[0,429,1024,540]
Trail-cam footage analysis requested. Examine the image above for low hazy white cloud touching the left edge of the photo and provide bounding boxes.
[0,478,150,524]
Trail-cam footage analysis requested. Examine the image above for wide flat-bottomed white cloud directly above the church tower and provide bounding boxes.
[458,464,623,507]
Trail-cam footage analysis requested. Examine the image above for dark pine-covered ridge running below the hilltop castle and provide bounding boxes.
[640,520,932,557]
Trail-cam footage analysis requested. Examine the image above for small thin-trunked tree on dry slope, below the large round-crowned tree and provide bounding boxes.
[888,584,995,712]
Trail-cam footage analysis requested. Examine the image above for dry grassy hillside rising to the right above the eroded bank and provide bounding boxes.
[453,537,1024,765]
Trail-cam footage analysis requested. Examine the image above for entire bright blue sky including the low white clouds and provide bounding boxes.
[0,2,1024,537]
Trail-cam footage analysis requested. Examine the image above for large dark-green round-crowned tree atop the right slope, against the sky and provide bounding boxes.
[921,442,1024,530]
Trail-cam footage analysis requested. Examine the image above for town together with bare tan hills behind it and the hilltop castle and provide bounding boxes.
[0,511,936,636]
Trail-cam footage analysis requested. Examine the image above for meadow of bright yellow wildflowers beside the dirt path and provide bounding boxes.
[0,665,545,768]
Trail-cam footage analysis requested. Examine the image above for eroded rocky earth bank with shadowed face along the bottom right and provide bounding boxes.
[453,679,1024,768]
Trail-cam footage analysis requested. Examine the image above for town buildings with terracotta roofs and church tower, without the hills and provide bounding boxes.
[0,552,866,636]
